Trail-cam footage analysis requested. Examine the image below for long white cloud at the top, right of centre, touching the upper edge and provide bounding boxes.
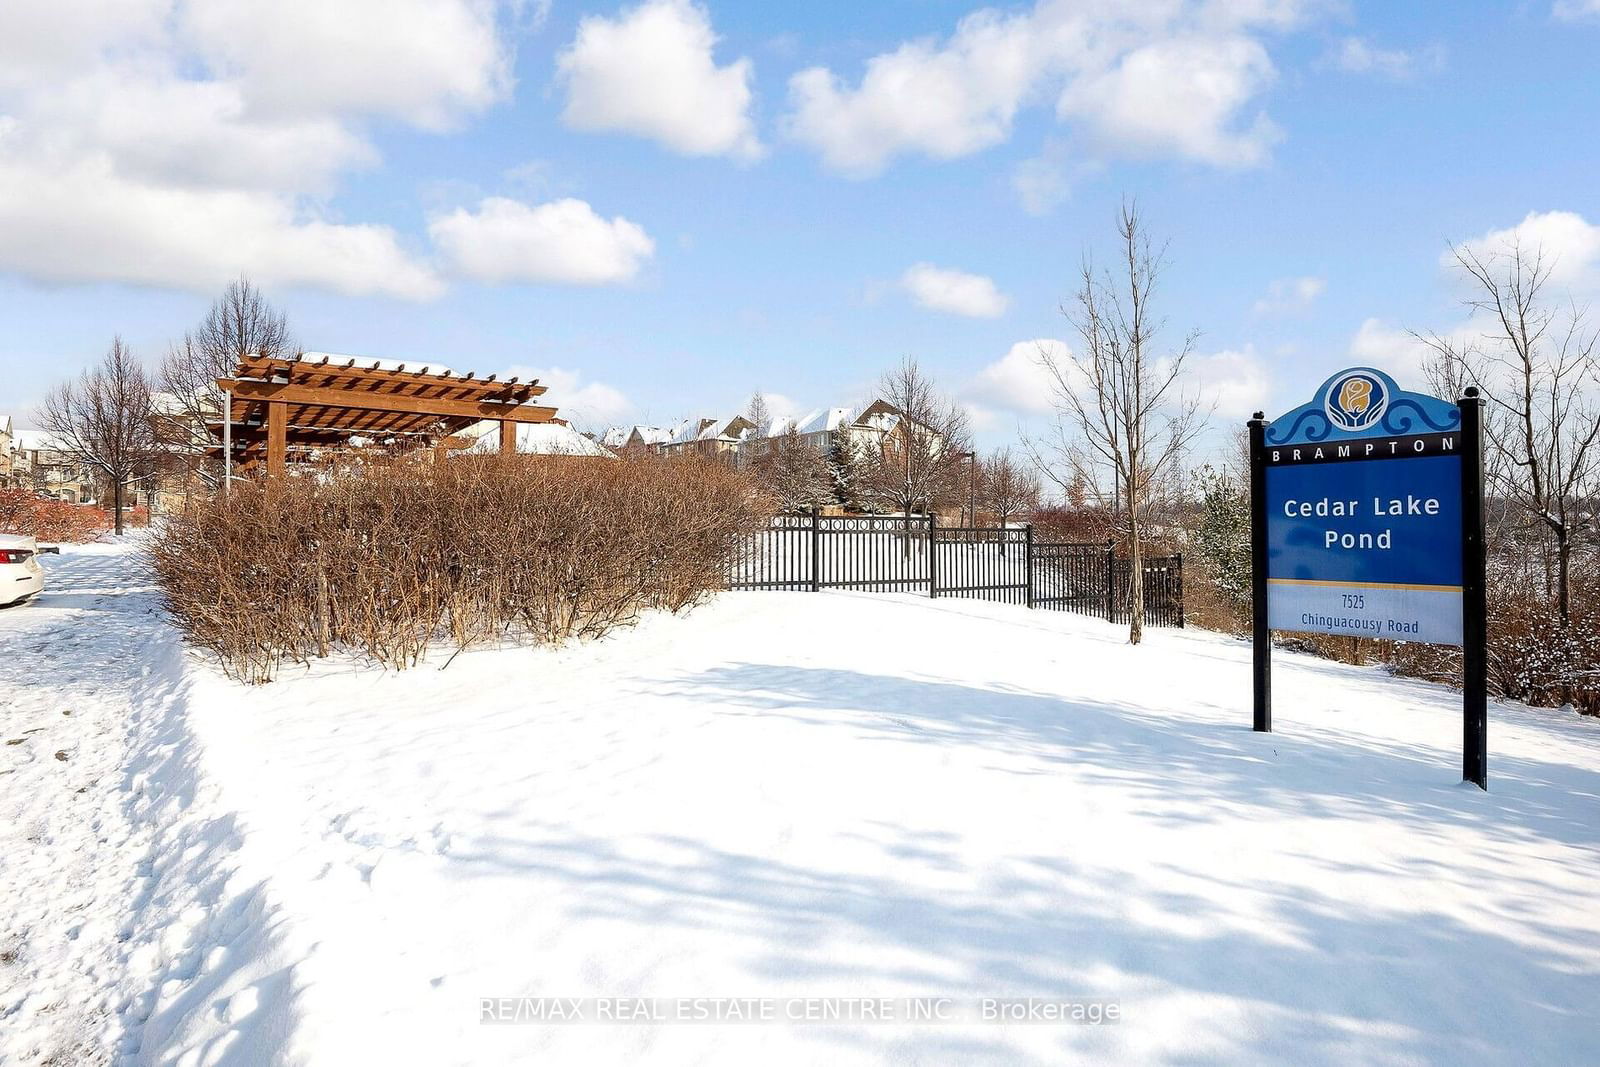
[786,0,1317,178]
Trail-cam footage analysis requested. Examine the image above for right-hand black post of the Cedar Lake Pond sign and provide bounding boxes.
[1459,386,1490,789]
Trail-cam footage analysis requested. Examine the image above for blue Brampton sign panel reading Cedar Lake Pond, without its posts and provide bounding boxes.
[1258,366,1464,645]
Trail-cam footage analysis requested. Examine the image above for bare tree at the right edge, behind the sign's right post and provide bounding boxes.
[1411,238,1600,627]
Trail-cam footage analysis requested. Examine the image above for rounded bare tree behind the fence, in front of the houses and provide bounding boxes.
[864,357,968,552]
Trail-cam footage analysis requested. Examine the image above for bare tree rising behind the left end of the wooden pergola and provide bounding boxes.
[158,278,296,485]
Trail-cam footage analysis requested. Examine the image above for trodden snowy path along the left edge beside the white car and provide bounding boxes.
[0,542,292,1065]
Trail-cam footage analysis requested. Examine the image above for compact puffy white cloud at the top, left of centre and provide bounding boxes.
[557,0,762,160]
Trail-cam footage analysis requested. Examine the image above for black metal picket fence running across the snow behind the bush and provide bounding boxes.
[728,515,1184,625]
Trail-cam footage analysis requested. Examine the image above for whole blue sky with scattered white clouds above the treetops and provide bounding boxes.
[0,0,1600,446]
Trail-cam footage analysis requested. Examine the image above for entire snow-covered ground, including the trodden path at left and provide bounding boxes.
[0,549,1600,1064]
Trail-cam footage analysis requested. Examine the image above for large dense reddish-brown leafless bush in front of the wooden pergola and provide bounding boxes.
[150,456,768,681]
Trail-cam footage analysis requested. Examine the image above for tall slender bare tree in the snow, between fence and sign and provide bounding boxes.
[1024,202,1205,645]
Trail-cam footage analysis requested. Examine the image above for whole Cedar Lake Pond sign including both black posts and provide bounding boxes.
[1250,366,1488,789]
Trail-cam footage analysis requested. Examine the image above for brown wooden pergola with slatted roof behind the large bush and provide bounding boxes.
[211,355,560,477]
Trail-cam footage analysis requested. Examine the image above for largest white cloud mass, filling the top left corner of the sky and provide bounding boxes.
[0,0,509,299]
